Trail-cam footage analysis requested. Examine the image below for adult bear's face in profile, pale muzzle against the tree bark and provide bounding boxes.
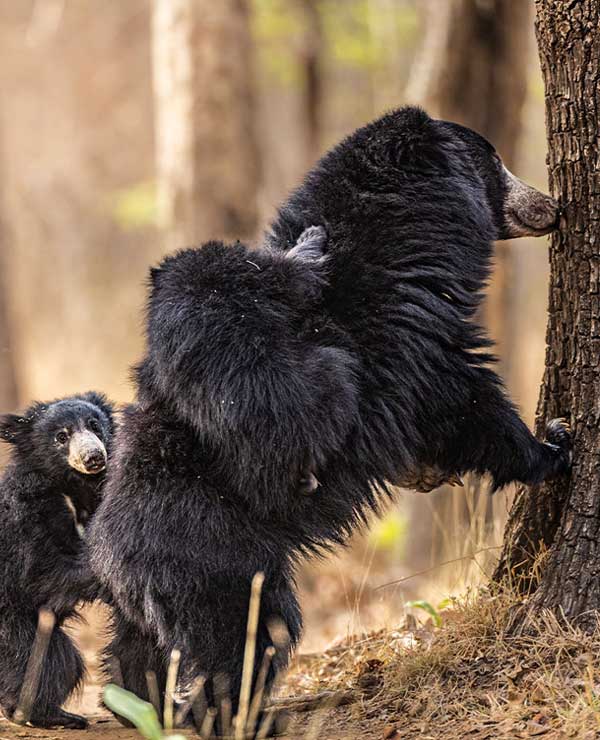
[438,121,559,239]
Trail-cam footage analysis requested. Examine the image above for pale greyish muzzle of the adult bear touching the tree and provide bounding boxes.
[500,167,559,239]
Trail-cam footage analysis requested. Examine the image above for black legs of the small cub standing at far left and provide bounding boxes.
[0,619,88,730]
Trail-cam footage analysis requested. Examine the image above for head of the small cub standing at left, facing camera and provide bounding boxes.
[0,392,114,481]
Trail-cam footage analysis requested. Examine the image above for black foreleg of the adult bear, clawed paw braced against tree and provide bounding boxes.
[441,371,571,489]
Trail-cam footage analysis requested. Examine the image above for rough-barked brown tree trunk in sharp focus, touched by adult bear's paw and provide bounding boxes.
[497,0,600,627]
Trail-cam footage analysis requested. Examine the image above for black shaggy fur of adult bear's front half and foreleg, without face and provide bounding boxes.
[268,108,570,498]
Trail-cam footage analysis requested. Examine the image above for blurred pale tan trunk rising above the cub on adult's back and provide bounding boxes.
[153,0,259,247]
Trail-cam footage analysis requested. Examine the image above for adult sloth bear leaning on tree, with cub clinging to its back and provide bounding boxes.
[90,108,569,732]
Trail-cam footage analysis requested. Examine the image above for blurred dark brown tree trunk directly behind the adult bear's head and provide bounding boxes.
[406,0,533,572]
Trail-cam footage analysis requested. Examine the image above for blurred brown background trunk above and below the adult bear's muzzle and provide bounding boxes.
[408,0,531,362]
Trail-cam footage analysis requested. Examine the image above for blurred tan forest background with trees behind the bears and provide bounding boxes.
[0,0,548,644]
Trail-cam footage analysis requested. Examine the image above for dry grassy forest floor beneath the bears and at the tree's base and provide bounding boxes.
[0,591,600,740]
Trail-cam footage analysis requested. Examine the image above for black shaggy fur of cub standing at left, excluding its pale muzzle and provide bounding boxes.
[0,392,113,728]
